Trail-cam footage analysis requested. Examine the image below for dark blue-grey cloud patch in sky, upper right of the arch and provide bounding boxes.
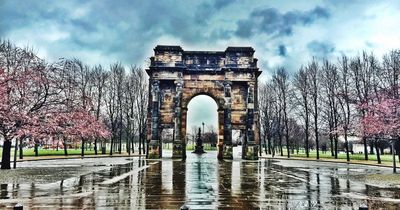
[235,7,329,38]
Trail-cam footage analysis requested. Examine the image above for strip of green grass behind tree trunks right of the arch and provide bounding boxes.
[277,150,397,162]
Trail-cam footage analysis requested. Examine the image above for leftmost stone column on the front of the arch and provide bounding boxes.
[148,80,161,159]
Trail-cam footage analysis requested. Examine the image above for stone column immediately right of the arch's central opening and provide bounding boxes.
[223,81,233,159]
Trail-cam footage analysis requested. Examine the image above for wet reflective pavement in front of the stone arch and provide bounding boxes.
[0,148,400,209]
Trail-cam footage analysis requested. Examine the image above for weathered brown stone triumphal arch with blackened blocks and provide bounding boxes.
[147,45,261,159]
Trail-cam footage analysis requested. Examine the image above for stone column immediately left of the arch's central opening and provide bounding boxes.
[172,80,186,158]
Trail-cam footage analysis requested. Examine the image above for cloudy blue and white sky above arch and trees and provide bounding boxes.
[0,0,400,135]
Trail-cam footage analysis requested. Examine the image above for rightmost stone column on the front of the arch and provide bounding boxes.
[243,82,258,160]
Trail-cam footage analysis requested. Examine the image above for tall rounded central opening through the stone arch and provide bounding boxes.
[186,95,218,155]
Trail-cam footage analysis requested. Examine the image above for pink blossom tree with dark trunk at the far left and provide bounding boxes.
[0,41,109,169]
